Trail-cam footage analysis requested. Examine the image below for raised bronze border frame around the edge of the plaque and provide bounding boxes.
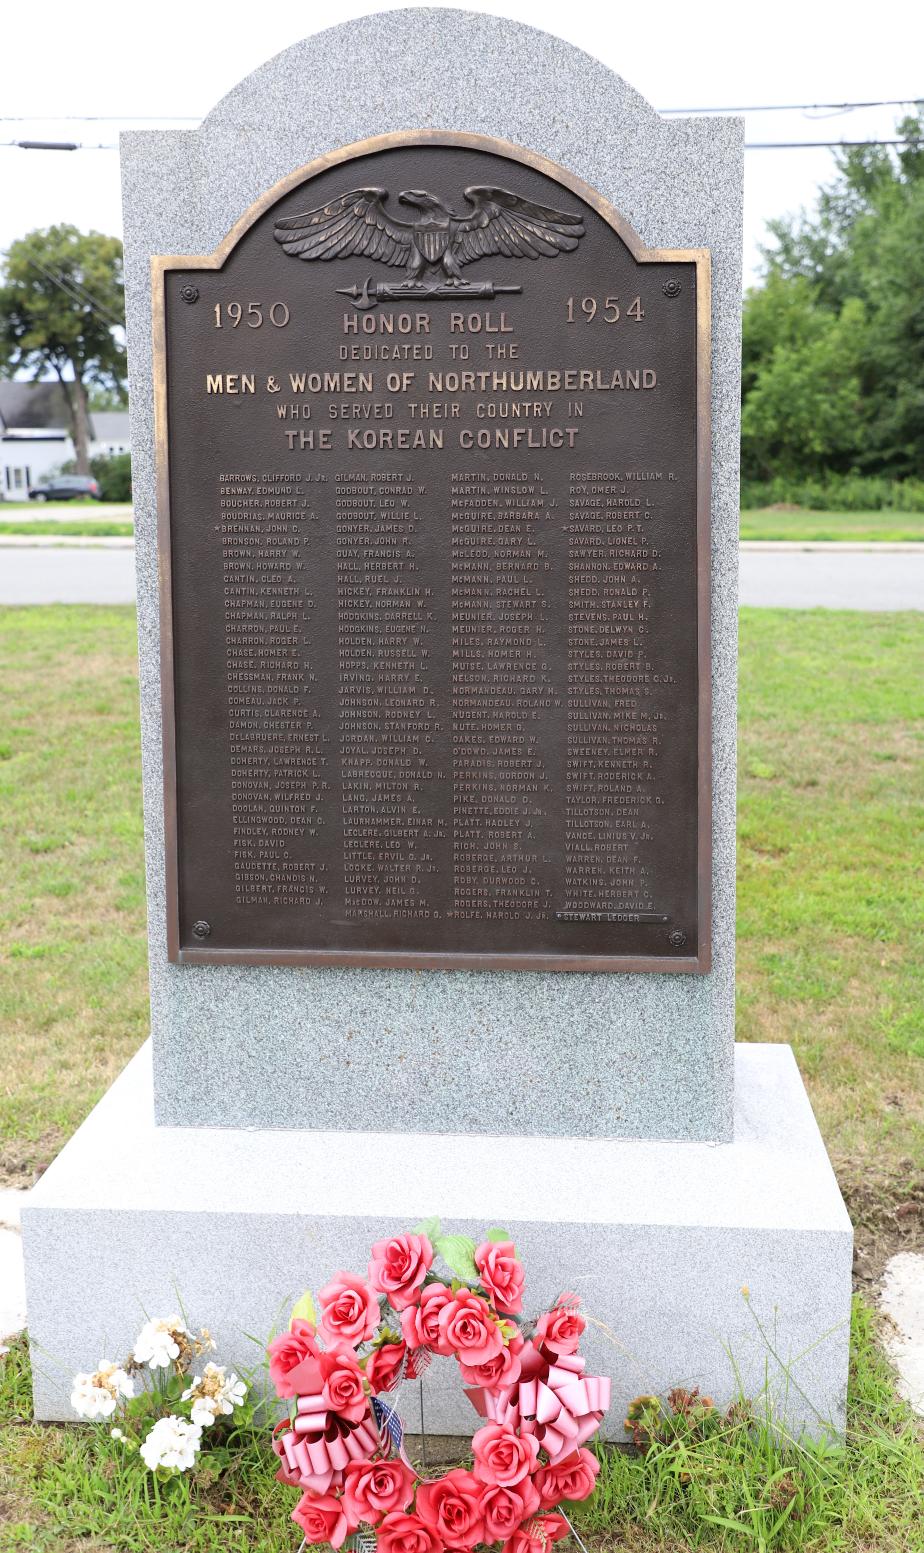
[151,129,713,975]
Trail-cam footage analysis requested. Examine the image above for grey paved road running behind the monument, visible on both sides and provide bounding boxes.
[0,539,924,610]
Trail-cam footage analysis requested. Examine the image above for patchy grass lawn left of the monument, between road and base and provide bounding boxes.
[0,607,148,1182]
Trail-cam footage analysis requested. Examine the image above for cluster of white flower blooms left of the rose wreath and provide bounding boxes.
[70,1315,247,1472]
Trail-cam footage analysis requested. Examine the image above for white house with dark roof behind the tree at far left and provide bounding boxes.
[0,382,130,502]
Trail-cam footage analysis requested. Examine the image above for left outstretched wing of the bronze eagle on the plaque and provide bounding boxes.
[273,189,413,264]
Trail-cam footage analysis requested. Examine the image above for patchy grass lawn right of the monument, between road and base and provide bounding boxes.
[738,609,924,1273]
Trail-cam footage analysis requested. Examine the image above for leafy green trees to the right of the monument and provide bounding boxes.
[742,113,924,478]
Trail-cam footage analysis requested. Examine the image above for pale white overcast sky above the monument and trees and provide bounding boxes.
[0,0,924,283]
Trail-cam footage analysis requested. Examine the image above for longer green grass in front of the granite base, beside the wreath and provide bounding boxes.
[0,1300,924,1553]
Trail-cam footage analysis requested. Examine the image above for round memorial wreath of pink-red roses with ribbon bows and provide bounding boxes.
[269,1219,610,1553]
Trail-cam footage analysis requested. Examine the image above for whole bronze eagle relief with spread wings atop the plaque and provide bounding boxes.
[273,185,584,307]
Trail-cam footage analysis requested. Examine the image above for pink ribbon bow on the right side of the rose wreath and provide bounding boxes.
[485,1354,610,1466]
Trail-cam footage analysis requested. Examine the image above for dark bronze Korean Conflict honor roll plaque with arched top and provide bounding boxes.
[154,132,710,971]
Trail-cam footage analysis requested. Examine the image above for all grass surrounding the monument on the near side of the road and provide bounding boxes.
[0,607,924,1553]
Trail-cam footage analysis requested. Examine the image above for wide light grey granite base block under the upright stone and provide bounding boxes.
[22,1045,853,1438]
